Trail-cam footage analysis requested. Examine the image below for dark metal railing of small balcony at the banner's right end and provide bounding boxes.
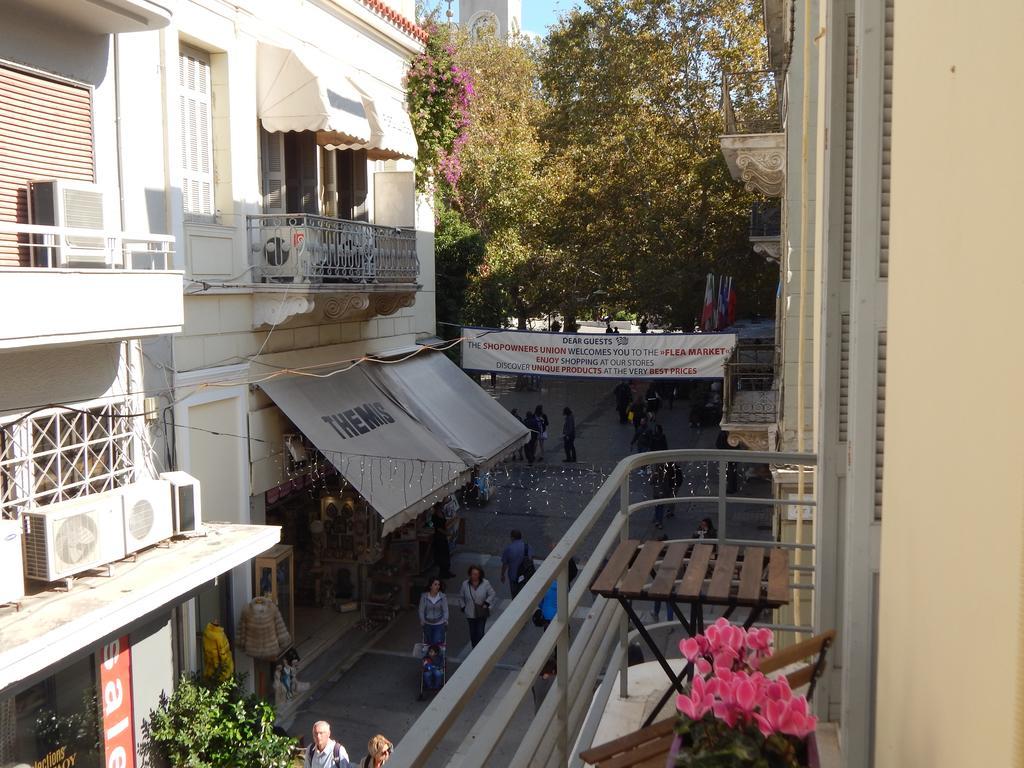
[722,342,779,424]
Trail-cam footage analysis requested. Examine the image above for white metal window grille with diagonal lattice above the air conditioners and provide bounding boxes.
[0,400,135,518]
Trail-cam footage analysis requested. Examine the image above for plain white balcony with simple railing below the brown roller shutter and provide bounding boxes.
[0,222,183,349]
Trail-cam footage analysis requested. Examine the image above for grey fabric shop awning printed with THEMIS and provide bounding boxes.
[260,366,469,535]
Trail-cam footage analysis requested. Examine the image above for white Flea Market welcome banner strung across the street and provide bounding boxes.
[462,328,736,379]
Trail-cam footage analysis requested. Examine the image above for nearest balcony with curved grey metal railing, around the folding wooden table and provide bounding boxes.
[389,451,823,768]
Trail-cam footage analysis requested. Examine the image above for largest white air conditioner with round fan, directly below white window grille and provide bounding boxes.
[24,490,125,582]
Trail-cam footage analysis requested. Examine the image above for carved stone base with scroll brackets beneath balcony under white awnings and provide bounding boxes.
[253,286,416,329]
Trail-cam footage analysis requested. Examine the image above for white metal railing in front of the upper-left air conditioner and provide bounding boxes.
[0,221,174,270]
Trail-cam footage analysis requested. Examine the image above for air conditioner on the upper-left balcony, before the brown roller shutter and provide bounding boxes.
[29,179,113,267]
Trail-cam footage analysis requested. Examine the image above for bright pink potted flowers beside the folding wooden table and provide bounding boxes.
[675,618,817,768]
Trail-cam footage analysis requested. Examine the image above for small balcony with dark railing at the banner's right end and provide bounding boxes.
[721,339,779,451]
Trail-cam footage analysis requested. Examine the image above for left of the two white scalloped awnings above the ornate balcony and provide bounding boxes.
[256,43,373,144]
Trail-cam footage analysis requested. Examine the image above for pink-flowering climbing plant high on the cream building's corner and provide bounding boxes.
[406,23,474,190]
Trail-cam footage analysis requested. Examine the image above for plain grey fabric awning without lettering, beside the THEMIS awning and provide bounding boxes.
[366,351,529,468]
